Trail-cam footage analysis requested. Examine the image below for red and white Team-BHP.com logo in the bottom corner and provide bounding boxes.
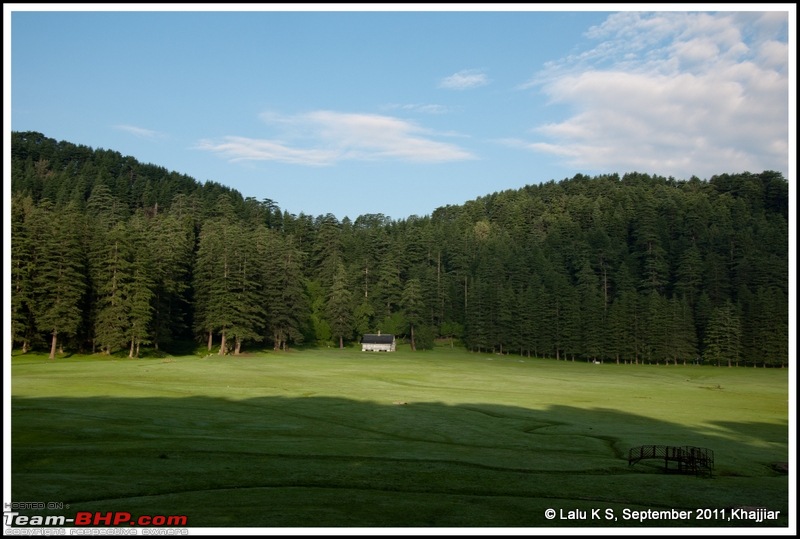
[3,511,188,527]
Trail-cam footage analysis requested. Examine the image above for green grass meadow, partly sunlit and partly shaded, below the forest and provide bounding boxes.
[11,348,790,528]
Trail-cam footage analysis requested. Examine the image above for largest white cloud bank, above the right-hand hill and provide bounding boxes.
[517,13,789,177]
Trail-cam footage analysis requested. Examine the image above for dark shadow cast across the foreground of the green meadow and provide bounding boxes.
[11,397,789,527]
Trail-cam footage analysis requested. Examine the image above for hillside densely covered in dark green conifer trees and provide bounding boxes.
[10,132,789,366]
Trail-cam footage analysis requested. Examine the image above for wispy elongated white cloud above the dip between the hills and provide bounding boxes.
[198,111,474,166]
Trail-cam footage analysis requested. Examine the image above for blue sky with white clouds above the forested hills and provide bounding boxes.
[4,4,795,219]
